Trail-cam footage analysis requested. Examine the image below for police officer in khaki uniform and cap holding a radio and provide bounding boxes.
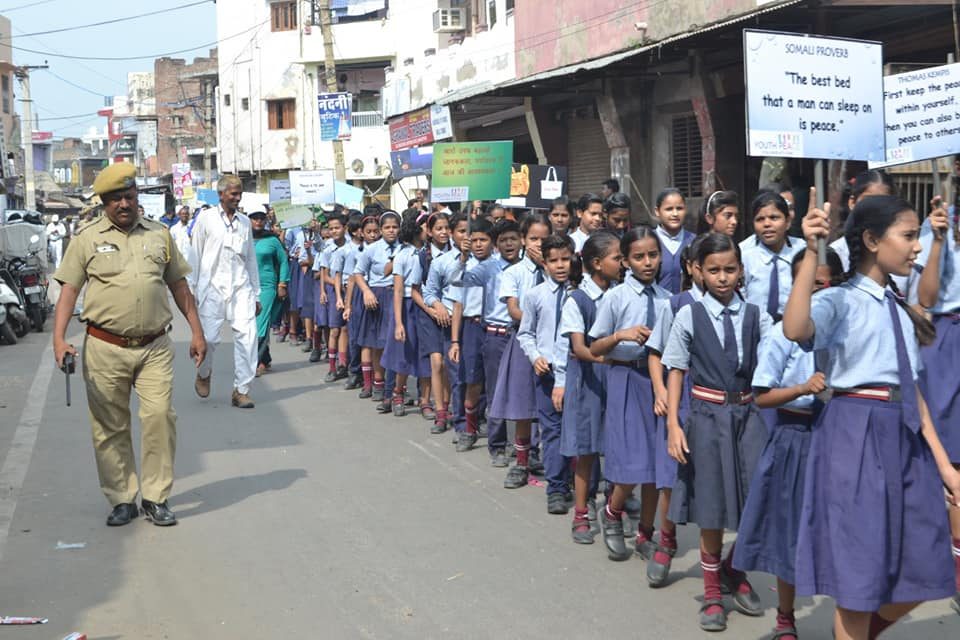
[53,163,207,526]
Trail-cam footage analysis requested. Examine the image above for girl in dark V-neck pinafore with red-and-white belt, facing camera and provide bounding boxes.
[661,232,772,631]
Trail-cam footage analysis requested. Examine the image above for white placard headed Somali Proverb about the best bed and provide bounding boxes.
[743,29,886,161]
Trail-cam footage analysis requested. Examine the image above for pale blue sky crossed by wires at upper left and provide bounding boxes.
[0,0,216,137]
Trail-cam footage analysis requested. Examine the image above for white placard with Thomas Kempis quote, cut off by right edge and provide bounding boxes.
[870,63,960,168]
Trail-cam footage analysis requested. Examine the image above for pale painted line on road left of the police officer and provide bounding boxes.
[0,346,53,560]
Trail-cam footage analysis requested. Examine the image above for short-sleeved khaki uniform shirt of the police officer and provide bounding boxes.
[53,215,190,338]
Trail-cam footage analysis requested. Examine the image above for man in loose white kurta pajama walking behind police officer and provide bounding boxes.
[190,176,260,409]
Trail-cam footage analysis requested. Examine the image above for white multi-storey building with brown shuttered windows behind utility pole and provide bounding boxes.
[217,0,394,200]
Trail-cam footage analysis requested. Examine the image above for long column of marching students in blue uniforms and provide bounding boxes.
[258,171,960,639]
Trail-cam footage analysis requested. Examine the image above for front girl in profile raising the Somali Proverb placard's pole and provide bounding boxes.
[784,195,960,624]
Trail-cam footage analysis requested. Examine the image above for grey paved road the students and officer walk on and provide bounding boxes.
[0,304,960,640]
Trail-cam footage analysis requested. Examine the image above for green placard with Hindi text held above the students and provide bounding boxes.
[430,140,513,202]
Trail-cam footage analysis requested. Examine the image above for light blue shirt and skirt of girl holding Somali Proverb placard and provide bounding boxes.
[796,270,955,611]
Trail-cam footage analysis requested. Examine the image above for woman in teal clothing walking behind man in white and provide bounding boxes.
[248,211,290,376]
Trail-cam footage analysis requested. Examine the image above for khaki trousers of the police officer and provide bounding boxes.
[83,334,177,506]
